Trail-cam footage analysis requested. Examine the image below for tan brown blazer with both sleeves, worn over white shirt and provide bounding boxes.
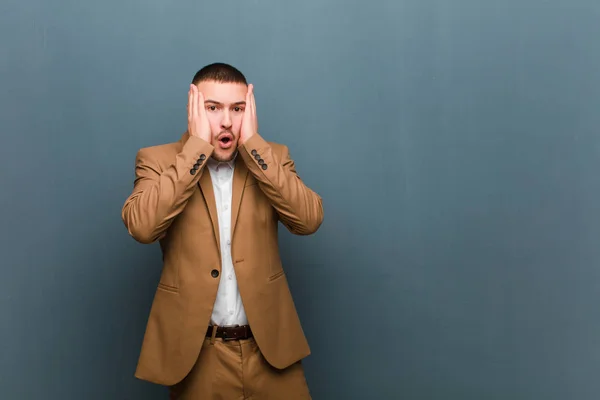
[122,133,323,385]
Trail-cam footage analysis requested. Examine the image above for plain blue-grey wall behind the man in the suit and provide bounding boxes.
[0,0,600,400]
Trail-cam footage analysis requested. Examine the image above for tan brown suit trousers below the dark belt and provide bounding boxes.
[170,338,311,400]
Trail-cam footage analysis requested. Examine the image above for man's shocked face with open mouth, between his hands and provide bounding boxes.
[198,81,248,161]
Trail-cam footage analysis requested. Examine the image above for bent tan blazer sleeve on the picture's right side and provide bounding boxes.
[239,134,323,235]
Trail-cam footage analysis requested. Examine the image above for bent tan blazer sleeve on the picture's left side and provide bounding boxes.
[121,136,214,243]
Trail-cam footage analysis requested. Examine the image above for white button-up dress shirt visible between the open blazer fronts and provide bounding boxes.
[207,155,248,326]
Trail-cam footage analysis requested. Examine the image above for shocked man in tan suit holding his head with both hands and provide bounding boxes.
[122,63,323,400]
